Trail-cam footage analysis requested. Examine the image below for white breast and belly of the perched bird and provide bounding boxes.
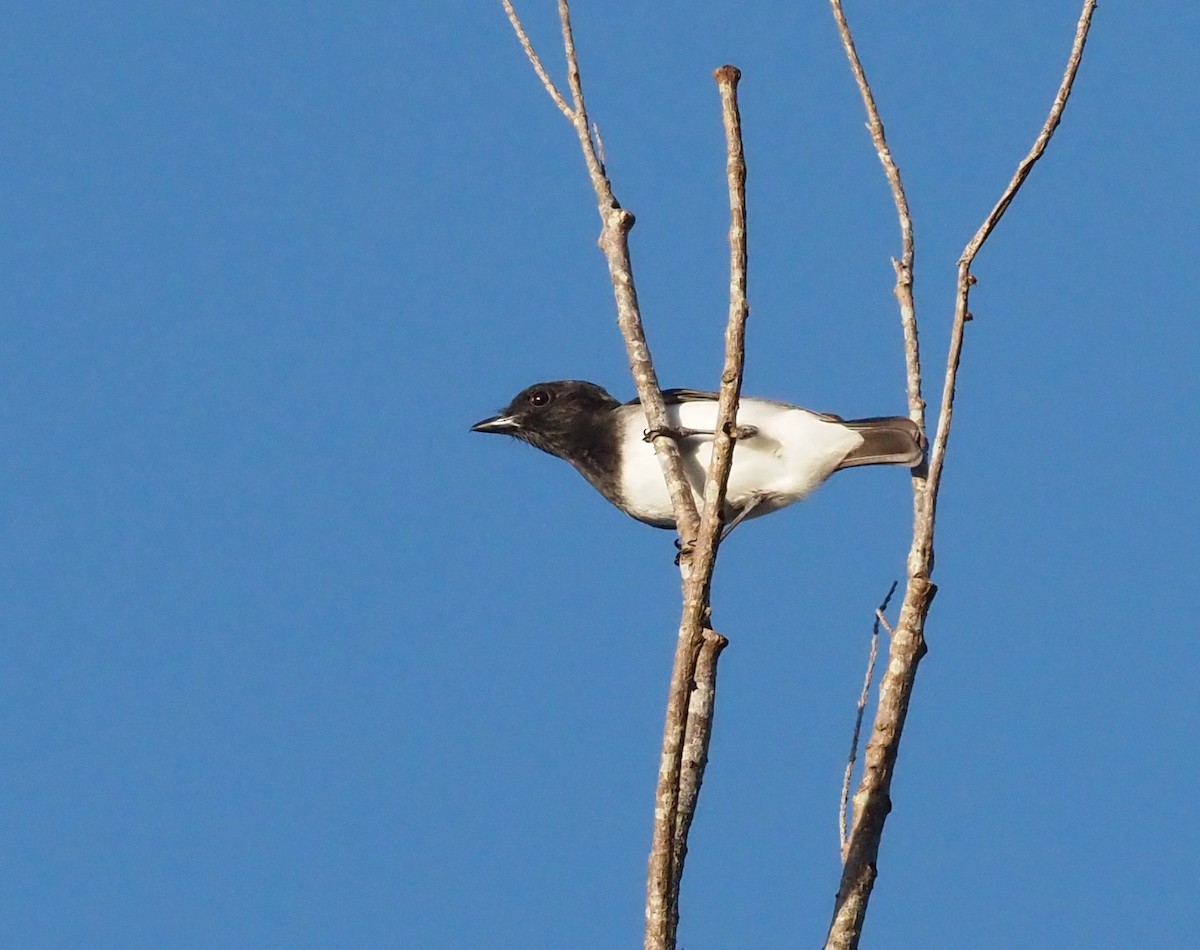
[620,398,863,523]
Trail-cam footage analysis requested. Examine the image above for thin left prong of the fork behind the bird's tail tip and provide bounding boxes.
[829,0,925,428]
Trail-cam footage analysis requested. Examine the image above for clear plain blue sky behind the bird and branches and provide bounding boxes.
[0,0,1200,950]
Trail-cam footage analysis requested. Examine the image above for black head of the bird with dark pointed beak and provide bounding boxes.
[470,379,620,458]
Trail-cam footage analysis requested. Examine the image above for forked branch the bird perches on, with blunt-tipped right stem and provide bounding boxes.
[500,0,749,950]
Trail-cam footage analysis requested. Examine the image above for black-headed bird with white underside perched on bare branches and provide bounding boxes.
[470,379,926,534]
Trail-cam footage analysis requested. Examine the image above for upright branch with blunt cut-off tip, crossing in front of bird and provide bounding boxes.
[646,66,750,950]
